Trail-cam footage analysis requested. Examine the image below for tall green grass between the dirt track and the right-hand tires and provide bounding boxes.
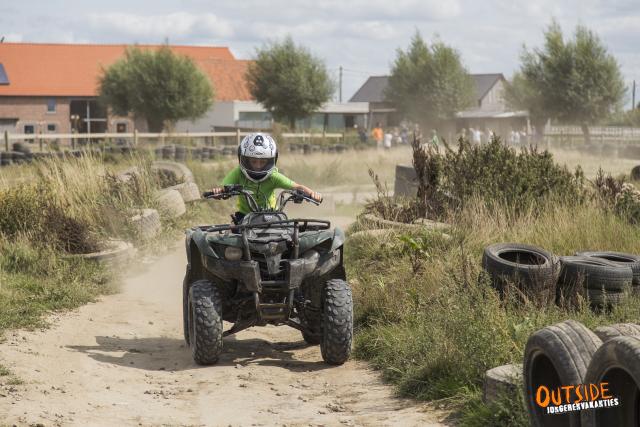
[345,202,640,426]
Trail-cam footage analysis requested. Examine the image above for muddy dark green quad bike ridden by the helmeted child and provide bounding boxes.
[182,185,353,365]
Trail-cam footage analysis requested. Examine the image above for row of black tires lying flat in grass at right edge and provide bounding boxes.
[482,243,640,309]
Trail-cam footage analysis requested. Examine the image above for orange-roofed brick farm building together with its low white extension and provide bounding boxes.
[0,43,369,134]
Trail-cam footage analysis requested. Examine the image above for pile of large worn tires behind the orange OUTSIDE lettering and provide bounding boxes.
[516,320,640,427]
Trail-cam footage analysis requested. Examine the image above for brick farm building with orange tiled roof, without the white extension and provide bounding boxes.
[0,43,251,133]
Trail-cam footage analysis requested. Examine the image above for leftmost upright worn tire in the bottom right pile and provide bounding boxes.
[523,320,602,427]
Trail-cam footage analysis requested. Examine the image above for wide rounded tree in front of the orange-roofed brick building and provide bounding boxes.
[99,46,214,132]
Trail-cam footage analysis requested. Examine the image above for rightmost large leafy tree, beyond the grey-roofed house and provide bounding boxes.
[508,21,626,142]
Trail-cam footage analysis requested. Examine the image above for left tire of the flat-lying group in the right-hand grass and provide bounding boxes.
[482,243,560,305]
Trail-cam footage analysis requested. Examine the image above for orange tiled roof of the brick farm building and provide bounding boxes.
[0,43,251,101]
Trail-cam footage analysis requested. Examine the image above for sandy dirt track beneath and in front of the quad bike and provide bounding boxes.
[0,206,448,426]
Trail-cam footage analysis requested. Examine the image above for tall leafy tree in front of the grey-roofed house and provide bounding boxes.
[385,31,474,123]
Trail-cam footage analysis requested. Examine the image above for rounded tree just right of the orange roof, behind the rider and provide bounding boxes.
[247,36,335,129]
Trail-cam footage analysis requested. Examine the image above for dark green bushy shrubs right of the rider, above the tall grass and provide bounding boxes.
[367,138,588,222]
